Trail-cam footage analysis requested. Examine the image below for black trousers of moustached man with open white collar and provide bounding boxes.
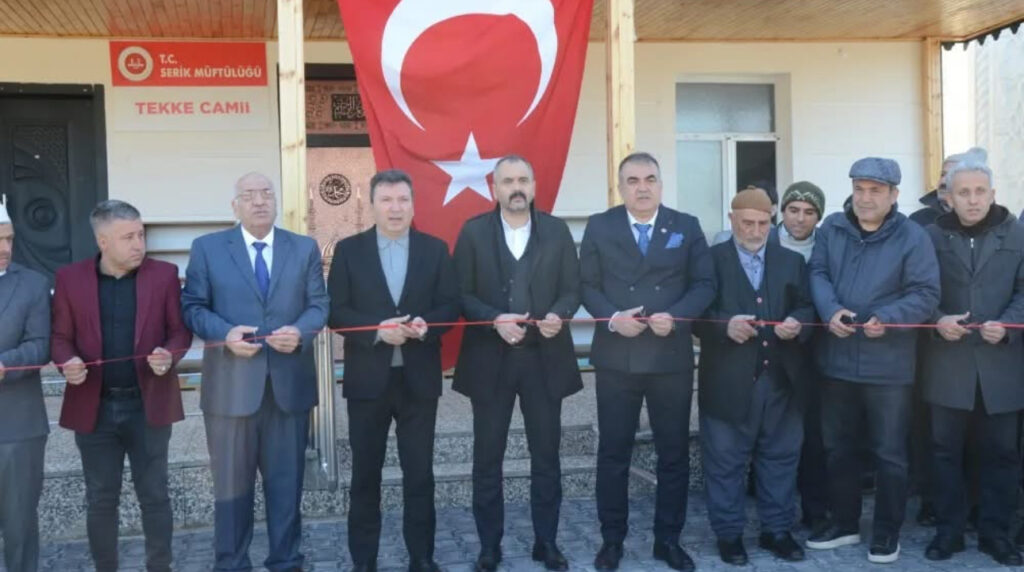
[472,347,562,546]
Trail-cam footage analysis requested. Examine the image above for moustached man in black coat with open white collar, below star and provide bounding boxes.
[453,156,583,571]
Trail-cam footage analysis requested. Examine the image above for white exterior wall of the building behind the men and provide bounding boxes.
[0,38,924,230]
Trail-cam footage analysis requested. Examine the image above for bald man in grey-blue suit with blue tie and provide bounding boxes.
[181,173,329,572]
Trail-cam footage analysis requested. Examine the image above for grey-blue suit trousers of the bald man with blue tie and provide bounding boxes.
[203,379,309,572]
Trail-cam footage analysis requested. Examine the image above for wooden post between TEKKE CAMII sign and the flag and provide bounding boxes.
[278,0,309,234]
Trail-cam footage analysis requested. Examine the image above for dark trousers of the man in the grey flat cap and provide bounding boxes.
[821,380,911,535]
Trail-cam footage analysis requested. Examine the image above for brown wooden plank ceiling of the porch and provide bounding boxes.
[0,0,1024,41]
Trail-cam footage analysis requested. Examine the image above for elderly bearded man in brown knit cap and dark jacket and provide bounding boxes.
[695,189,814,566]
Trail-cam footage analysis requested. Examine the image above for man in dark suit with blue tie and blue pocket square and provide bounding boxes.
[580,152,715,570]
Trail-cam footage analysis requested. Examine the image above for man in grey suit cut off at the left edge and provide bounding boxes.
[0,197,50,572]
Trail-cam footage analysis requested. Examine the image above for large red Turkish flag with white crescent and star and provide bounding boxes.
[338,0,603,364]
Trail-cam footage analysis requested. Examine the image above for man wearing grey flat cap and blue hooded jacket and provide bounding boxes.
[807,158,939,563]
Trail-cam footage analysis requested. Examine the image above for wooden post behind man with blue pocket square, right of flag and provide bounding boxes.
[604,0,637,207]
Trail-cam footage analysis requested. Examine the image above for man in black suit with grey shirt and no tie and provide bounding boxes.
[328,171,459,572]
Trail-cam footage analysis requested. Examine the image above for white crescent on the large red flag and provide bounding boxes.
[381,0,558,130]
